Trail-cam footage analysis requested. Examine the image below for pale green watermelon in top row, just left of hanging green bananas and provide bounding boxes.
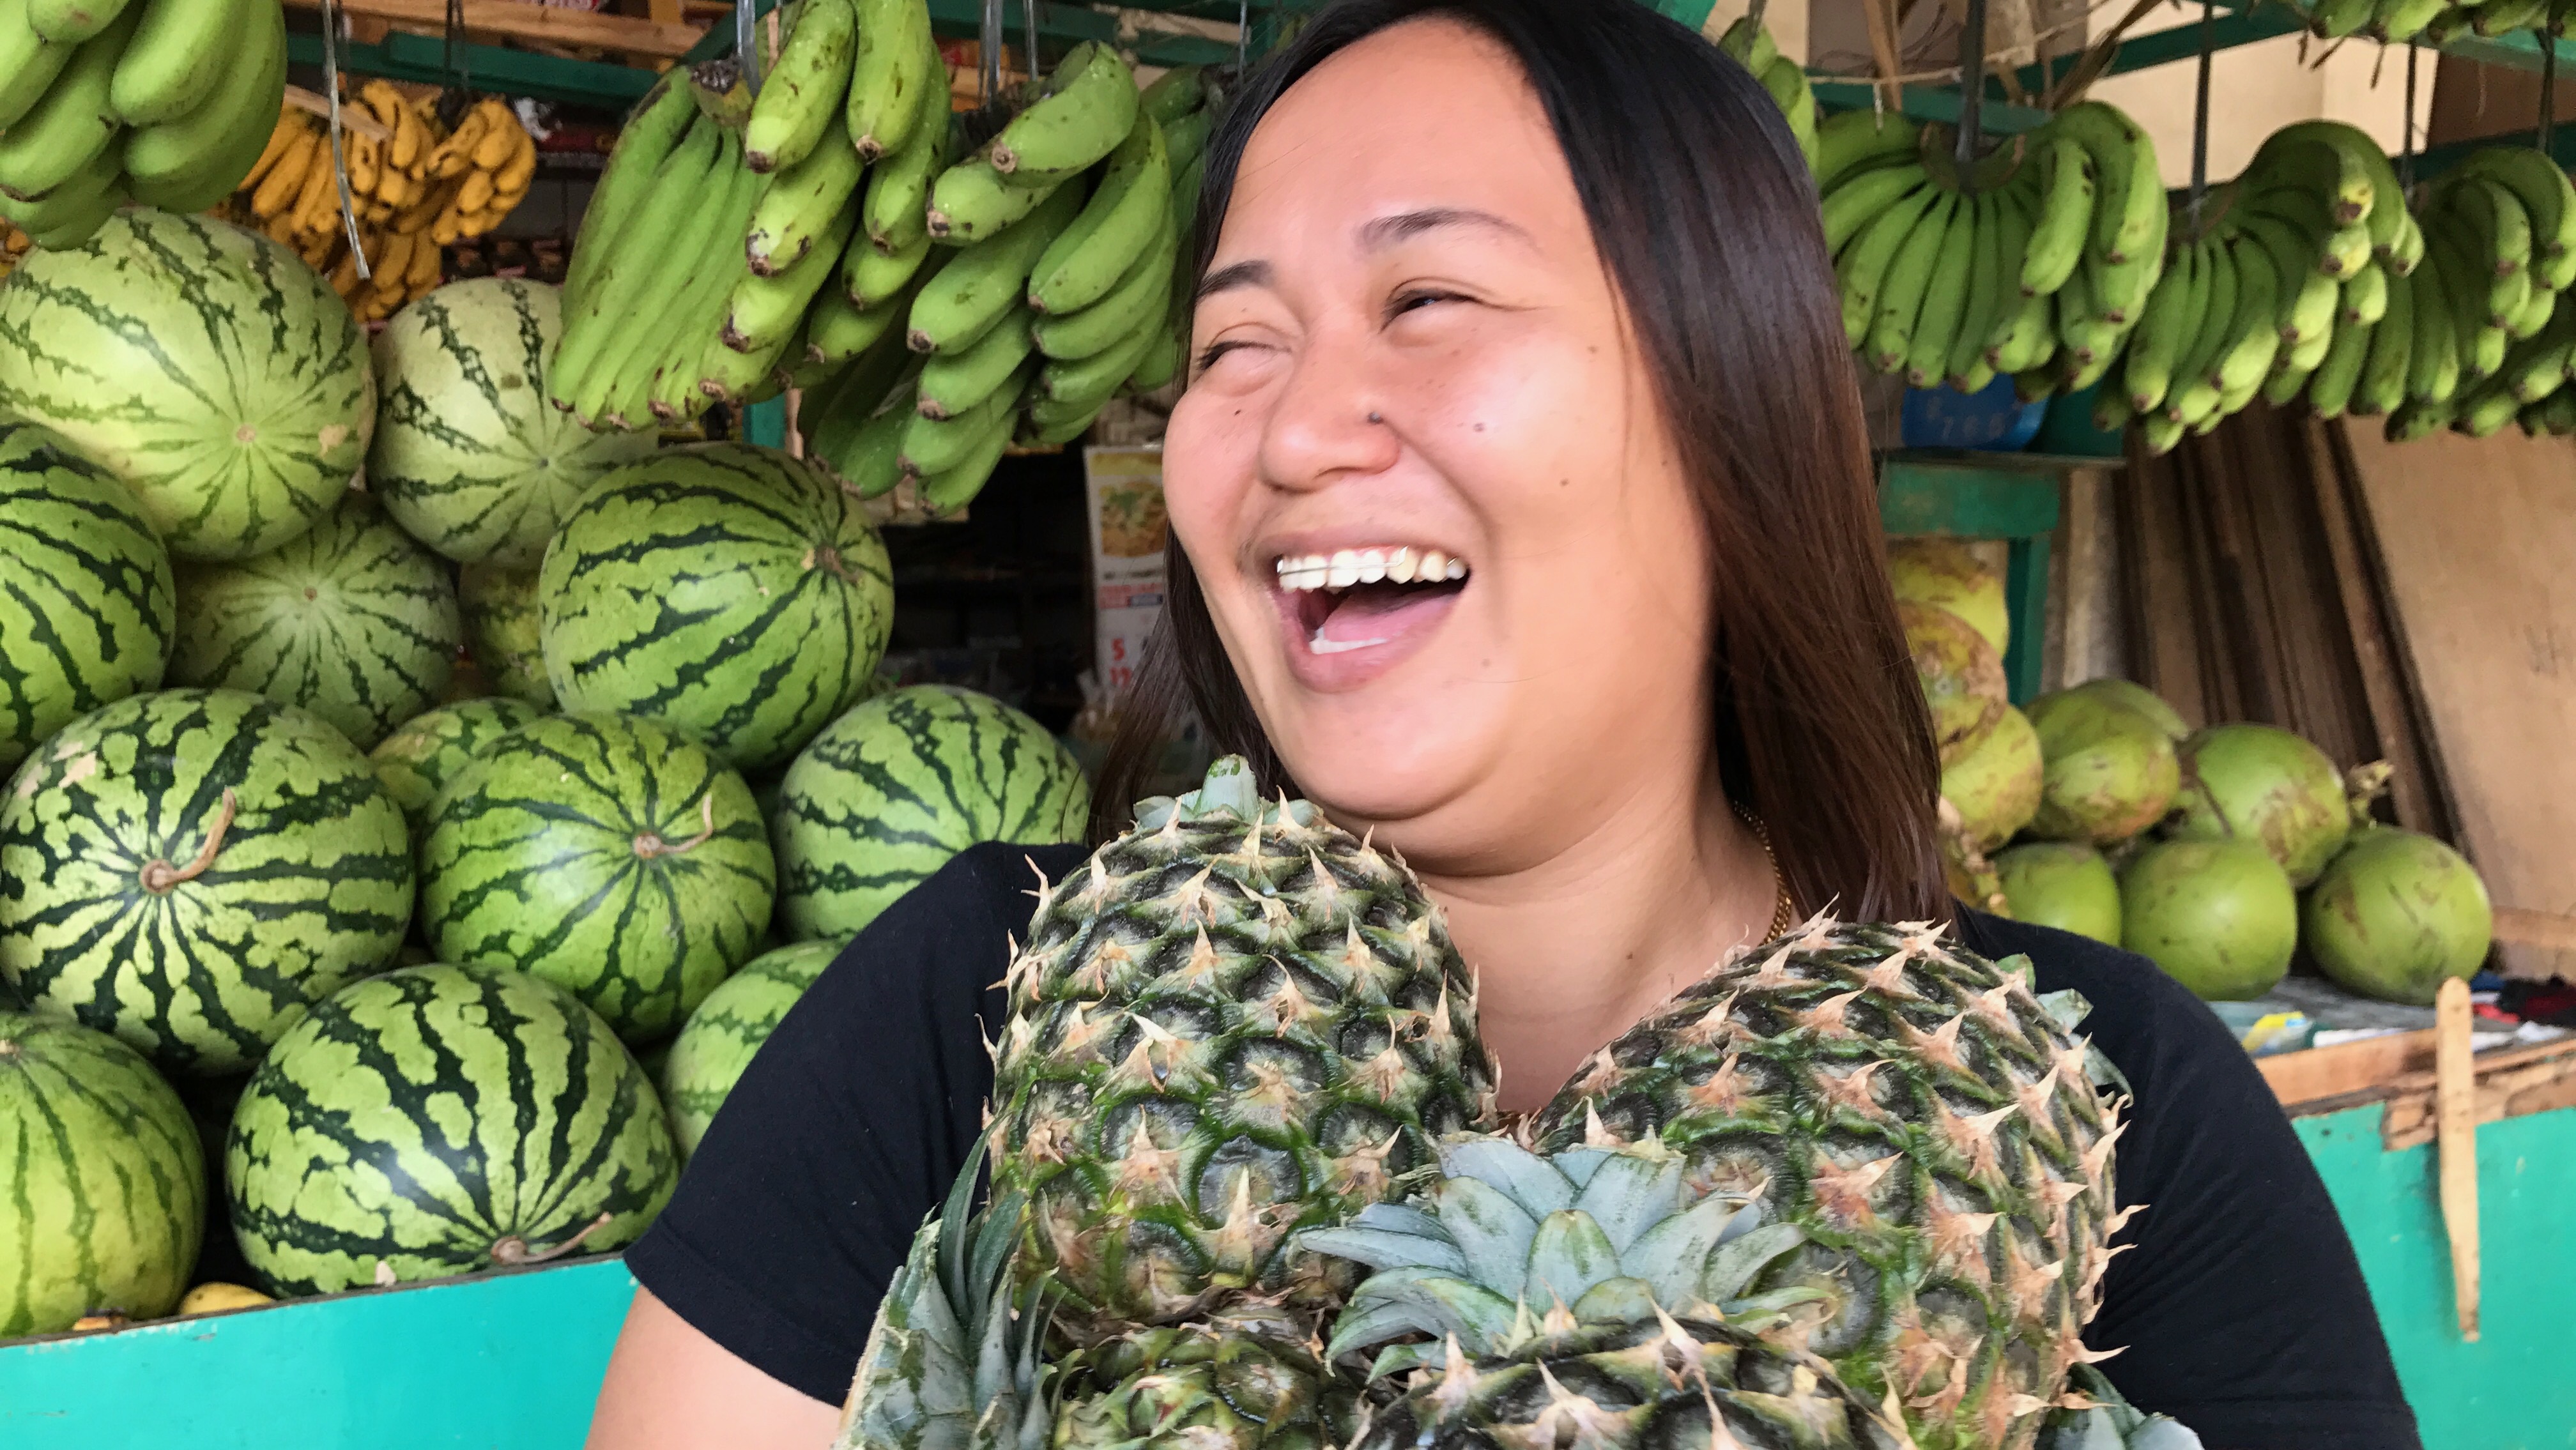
[366,278,659,569]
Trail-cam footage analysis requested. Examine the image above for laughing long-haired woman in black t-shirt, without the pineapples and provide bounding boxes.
[592,0,2416,1450]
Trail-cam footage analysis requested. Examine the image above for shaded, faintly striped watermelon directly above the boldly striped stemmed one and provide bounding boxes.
[170,494,464,749]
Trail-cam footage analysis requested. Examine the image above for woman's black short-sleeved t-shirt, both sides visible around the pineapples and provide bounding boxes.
[626,844,2419,1450]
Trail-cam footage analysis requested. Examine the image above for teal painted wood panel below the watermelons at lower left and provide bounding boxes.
[0,1260,636,1450]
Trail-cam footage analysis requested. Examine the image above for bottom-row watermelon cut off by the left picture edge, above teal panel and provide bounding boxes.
[0,1012,206,1339]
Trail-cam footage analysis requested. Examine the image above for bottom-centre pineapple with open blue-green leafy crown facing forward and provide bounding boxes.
[1301,1138,1906,1450]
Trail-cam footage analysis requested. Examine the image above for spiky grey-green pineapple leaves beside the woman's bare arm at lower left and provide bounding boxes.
[832,1143,1051,1450]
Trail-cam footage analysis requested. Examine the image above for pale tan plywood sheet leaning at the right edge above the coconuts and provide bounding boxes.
[2347,427,2576,979]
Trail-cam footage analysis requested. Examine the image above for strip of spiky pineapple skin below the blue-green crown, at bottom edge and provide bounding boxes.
[1353,1316,1904,1450]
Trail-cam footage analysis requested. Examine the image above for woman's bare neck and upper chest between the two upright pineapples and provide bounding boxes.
[1422,786,1777,1113]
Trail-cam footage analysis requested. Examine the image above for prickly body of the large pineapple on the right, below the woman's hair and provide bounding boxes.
[1533,919,2122,1450]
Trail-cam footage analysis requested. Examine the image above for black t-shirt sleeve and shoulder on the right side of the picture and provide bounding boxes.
[1970,919,2421,1450]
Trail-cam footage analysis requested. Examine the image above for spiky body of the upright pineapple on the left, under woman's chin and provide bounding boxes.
[994,801,1494,1342]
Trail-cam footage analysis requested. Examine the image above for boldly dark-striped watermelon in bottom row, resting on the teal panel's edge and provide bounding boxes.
[224,966,680,1293]
